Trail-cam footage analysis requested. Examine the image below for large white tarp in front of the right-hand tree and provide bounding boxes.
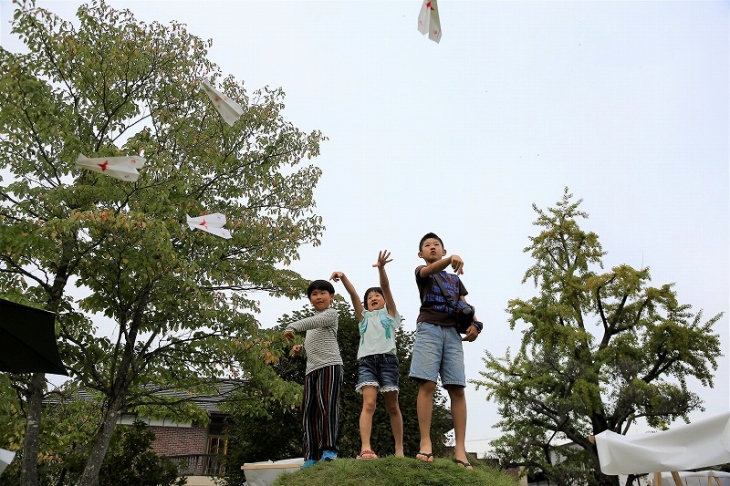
[595,412,730,475]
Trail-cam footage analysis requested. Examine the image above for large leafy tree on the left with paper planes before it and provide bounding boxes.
[0,0,324,485]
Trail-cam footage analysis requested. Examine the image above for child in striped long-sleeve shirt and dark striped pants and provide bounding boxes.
[284,280,343,469]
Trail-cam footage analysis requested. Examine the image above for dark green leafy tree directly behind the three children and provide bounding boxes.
[219,299,453,485]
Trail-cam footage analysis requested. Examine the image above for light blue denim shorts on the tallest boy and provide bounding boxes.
[409,322,466,387]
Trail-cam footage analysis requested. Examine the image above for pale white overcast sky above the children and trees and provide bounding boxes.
[0,0,730,453]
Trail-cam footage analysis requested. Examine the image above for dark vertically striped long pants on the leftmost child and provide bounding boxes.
[302,365,343,461]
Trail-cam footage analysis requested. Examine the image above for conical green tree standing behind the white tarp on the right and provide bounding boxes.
[475,188,722,485]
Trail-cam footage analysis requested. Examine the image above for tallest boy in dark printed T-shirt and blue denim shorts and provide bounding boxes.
[409,233,482,469]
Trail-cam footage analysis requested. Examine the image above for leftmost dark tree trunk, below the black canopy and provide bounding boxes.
[20,373,46,486]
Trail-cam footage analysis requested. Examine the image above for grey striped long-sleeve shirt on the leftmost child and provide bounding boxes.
[286,308,342,374]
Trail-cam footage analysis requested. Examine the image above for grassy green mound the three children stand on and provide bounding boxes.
[274,456,518,486]
